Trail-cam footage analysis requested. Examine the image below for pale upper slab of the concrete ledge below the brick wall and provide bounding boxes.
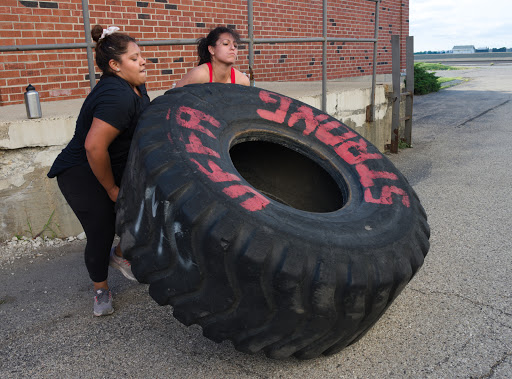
[0,80,390,149]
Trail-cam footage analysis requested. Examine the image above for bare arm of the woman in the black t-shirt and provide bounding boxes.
[85,117,121,202]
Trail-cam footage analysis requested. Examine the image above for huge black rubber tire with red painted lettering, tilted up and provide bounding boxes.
[117,83,430,359]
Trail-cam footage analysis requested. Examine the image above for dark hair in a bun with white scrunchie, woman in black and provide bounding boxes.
[91,25,137,75]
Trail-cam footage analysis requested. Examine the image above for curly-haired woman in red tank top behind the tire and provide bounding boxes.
[176,26,250,87]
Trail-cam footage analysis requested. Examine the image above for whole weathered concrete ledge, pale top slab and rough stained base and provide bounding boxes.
[0,80,392,240]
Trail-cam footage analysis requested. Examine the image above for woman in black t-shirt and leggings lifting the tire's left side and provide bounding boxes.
[48,25,149,316]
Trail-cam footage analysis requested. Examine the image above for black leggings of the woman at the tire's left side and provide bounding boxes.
[57,166,116,282]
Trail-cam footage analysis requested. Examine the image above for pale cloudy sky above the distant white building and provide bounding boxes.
[409,0,512,52]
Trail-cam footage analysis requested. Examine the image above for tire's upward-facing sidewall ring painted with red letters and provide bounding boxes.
[146,83,420,251]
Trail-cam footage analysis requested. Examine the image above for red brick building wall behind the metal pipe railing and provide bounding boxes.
[0,0,409,105]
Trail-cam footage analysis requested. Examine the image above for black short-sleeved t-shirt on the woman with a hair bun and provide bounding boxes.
[48,75,149,185]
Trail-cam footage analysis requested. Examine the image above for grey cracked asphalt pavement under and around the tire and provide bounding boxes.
[0,65,512,379]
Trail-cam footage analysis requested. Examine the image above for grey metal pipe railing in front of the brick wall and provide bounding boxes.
[0,0,382,116]
